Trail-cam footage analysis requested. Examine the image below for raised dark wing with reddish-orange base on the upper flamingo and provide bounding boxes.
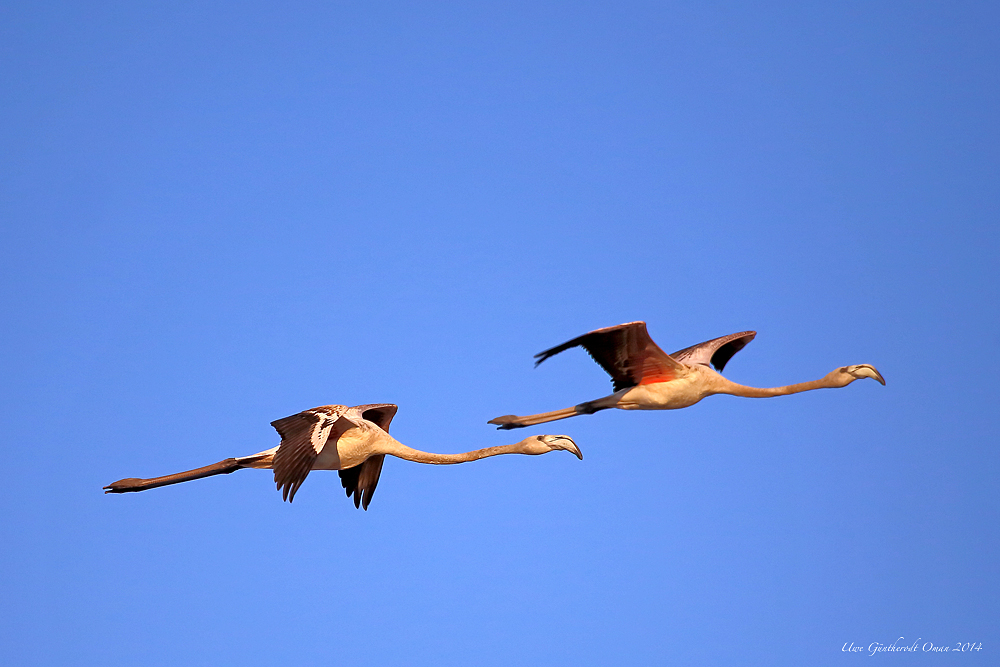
[535,322,684,391]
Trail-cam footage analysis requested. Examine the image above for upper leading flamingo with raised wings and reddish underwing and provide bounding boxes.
[488,322,885,429]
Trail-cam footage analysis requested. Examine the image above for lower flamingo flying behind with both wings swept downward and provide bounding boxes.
[104,403,583,510]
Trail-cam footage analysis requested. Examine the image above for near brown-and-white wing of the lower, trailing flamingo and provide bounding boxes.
[271,405,355,502]
